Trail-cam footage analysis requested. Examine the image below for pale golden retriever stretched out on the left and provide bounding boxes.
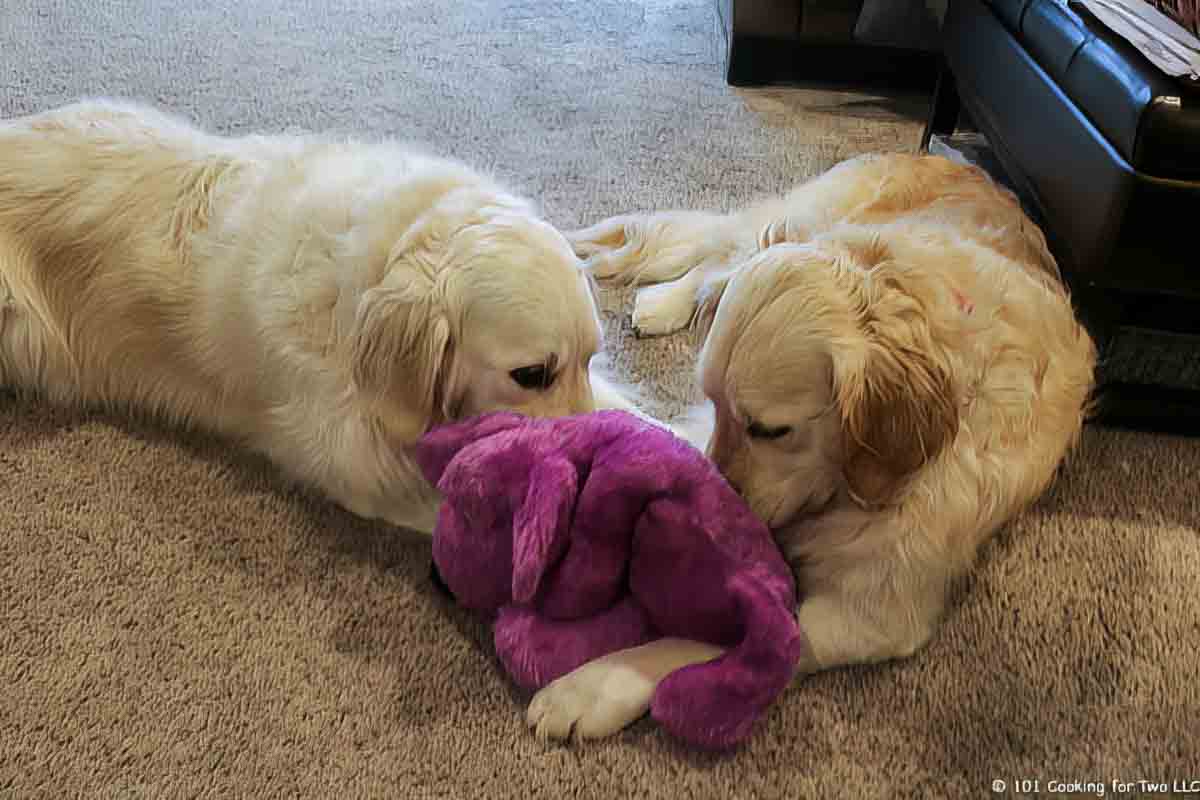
[0,101,622,530]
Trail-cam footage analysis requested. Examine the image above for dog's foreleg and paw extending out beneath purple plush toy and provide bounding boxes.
[526,639,722,740]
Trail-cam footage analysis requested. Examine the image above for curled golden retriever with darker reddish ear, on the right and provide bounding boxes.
[527,155,1096,738]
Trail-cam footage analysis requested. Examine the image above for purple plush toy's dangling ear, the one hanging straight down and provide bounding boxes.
[512,458,580,603]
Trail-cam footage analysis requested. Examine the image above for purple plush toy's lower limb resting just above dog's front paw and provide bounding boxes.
[492,599,652,688]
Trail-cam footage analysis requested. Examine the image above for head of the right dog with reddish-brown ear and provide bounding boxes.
[700,239,959,528]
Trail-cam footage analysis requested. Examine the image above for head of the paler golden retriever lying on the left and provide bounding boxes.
[348,188,601,438]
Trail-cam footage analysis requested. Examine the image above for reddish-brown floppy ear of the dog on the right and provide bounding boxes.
[834,267,959,506]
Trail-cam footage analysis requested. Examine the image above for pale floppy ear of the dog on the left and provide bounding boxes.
[350,264,451,435]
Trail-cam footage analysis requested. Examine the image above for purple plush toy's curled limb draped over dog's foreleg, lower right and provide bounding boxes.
[650,576,808,750]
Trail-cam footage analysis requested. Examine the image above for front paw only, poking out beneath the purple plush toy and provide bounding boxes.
[526,657,655,740]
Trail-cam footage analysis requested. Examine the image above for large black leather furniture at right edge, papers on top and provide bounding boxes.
[924,0,1200,429]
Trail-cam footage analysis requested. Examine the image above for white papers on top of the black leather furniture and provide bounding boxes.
[1070,0,1200,80]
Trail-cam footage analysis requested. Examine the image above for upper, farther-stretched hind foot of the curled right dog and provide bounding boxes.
[566,211,726,285]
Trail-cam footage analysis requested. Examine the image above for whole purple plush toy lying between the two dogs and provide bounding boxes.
[415,411,805,748]
